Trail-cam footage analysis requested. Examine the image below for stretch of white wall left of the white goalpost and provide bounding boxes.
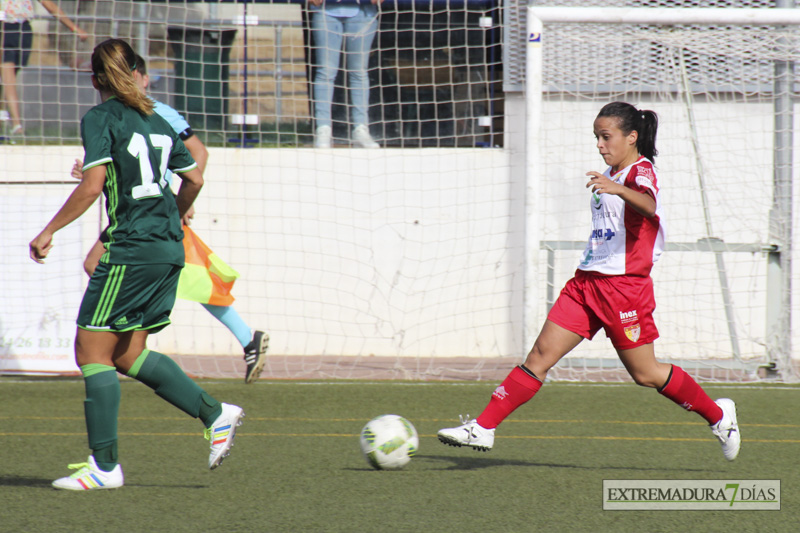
[0,143,523,372]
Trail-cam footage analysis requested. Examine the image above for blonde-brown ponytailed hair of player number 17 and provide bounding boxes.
[92,39,153,115]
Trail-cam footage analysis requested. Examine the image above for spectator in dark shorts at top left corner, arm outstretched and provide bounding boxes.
[0,0,89,136]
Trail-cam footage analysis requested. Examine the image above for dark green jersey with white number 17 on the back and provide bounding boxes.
[81,97,197,266]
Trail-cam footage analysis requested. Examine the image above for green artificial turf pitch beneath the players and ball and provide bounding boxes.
[0,378,800,533]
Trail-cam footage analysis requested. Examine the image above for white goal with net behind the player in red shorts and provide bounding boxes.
[525,6,800,380]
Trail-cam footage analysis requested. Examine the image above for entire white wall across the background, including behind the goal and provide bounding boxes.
[0,102,800,376]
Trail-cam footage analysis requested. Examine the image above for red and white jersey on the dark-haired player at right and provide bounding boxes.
[578,157,665,276]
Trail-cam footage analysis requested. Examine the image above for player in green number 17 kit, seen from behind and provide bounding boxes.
[30,39,244,491]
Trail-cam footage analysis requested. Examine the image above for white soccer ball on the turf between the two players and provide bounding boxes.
[360,415,419,470]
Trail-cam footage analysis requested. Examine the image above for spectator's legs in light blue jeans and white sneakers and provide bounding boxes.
[308,0,383,148]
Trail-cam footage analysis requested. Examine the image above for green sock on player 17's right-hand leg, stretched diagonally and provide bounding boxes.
[128,349,222,427]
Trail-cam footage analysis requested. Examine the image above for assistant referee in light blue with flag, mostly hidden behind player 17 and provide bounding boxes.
[78,54,269,384]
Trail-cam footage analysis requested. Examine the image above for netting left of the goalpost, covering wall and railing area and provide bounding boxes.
[0,0,512,379]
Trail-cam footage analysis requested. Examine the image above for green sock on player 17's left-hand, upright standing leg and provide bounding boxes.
[81,363,120,472]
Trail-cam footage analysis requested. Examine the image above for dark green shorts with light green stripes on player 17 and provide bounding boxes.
[78,263,182,333]
